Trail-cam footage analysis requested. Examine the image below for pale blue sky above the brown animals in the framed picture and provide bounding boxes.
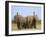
[11,5,41,19]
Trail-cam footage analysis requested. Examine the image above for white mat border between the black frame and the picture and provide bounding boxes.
[9,3,44,35]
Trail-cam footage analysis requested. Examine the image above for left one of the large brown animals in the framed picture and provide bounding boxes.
[16,16,26,29]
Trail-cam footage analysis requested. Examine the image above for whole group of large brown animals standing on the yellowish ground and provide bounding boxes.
[16,16,36,29]
